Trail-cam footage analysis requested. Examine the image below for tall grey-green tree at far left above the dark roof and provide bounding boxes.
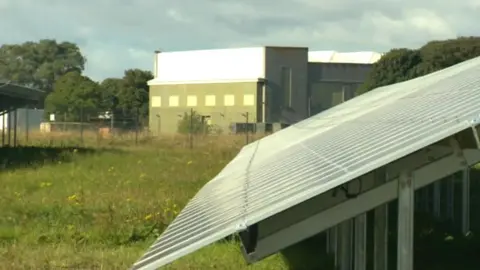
[0,39,86,92]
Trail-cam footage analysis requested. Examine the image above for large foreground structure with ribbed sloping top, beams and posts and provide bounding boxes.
[133,55,480,270]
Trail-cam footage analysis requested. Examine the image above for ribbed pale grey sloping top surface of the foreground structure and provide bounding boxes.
[134,58,480,269]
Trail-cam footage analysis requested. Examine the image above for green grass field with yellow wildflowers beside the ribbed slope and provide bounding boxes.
[0,132,480,270]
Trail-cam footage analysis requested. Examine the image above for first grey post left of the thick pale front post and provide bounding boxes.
[373,168,388,270]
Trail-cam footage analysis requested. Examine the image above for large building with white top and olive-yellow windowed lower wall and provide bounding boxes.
[148,46,380,134]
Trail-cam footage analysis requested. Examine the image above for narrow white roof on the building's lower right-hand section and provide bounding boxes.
[308,51,382,64]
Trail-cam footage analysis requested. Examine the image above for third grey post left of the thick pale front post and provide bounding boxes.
[337,219,353,270]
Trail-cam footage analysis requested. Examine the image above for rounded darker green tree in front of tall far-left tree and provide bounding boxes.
[45,71,101,121]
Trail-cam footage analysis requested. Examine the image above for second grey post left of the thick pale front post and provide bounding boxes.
[354,213,367,270]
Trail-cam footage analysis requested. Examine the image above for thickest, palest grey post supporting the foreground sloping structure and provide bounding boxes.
[397,171,415,270]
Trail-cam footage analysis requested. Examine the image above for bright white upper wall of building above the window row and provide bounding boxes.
[149,47,265,85]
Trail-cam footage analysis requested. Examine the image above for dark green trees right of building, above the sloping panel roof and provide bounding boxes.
[357,37,480,94]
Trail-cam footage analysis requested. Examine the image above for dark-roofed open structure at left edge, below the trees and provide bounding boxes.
[0,80,45,146]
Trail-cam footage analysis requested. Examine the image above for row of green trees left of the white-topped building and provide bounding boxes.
[0,39,153,121]
